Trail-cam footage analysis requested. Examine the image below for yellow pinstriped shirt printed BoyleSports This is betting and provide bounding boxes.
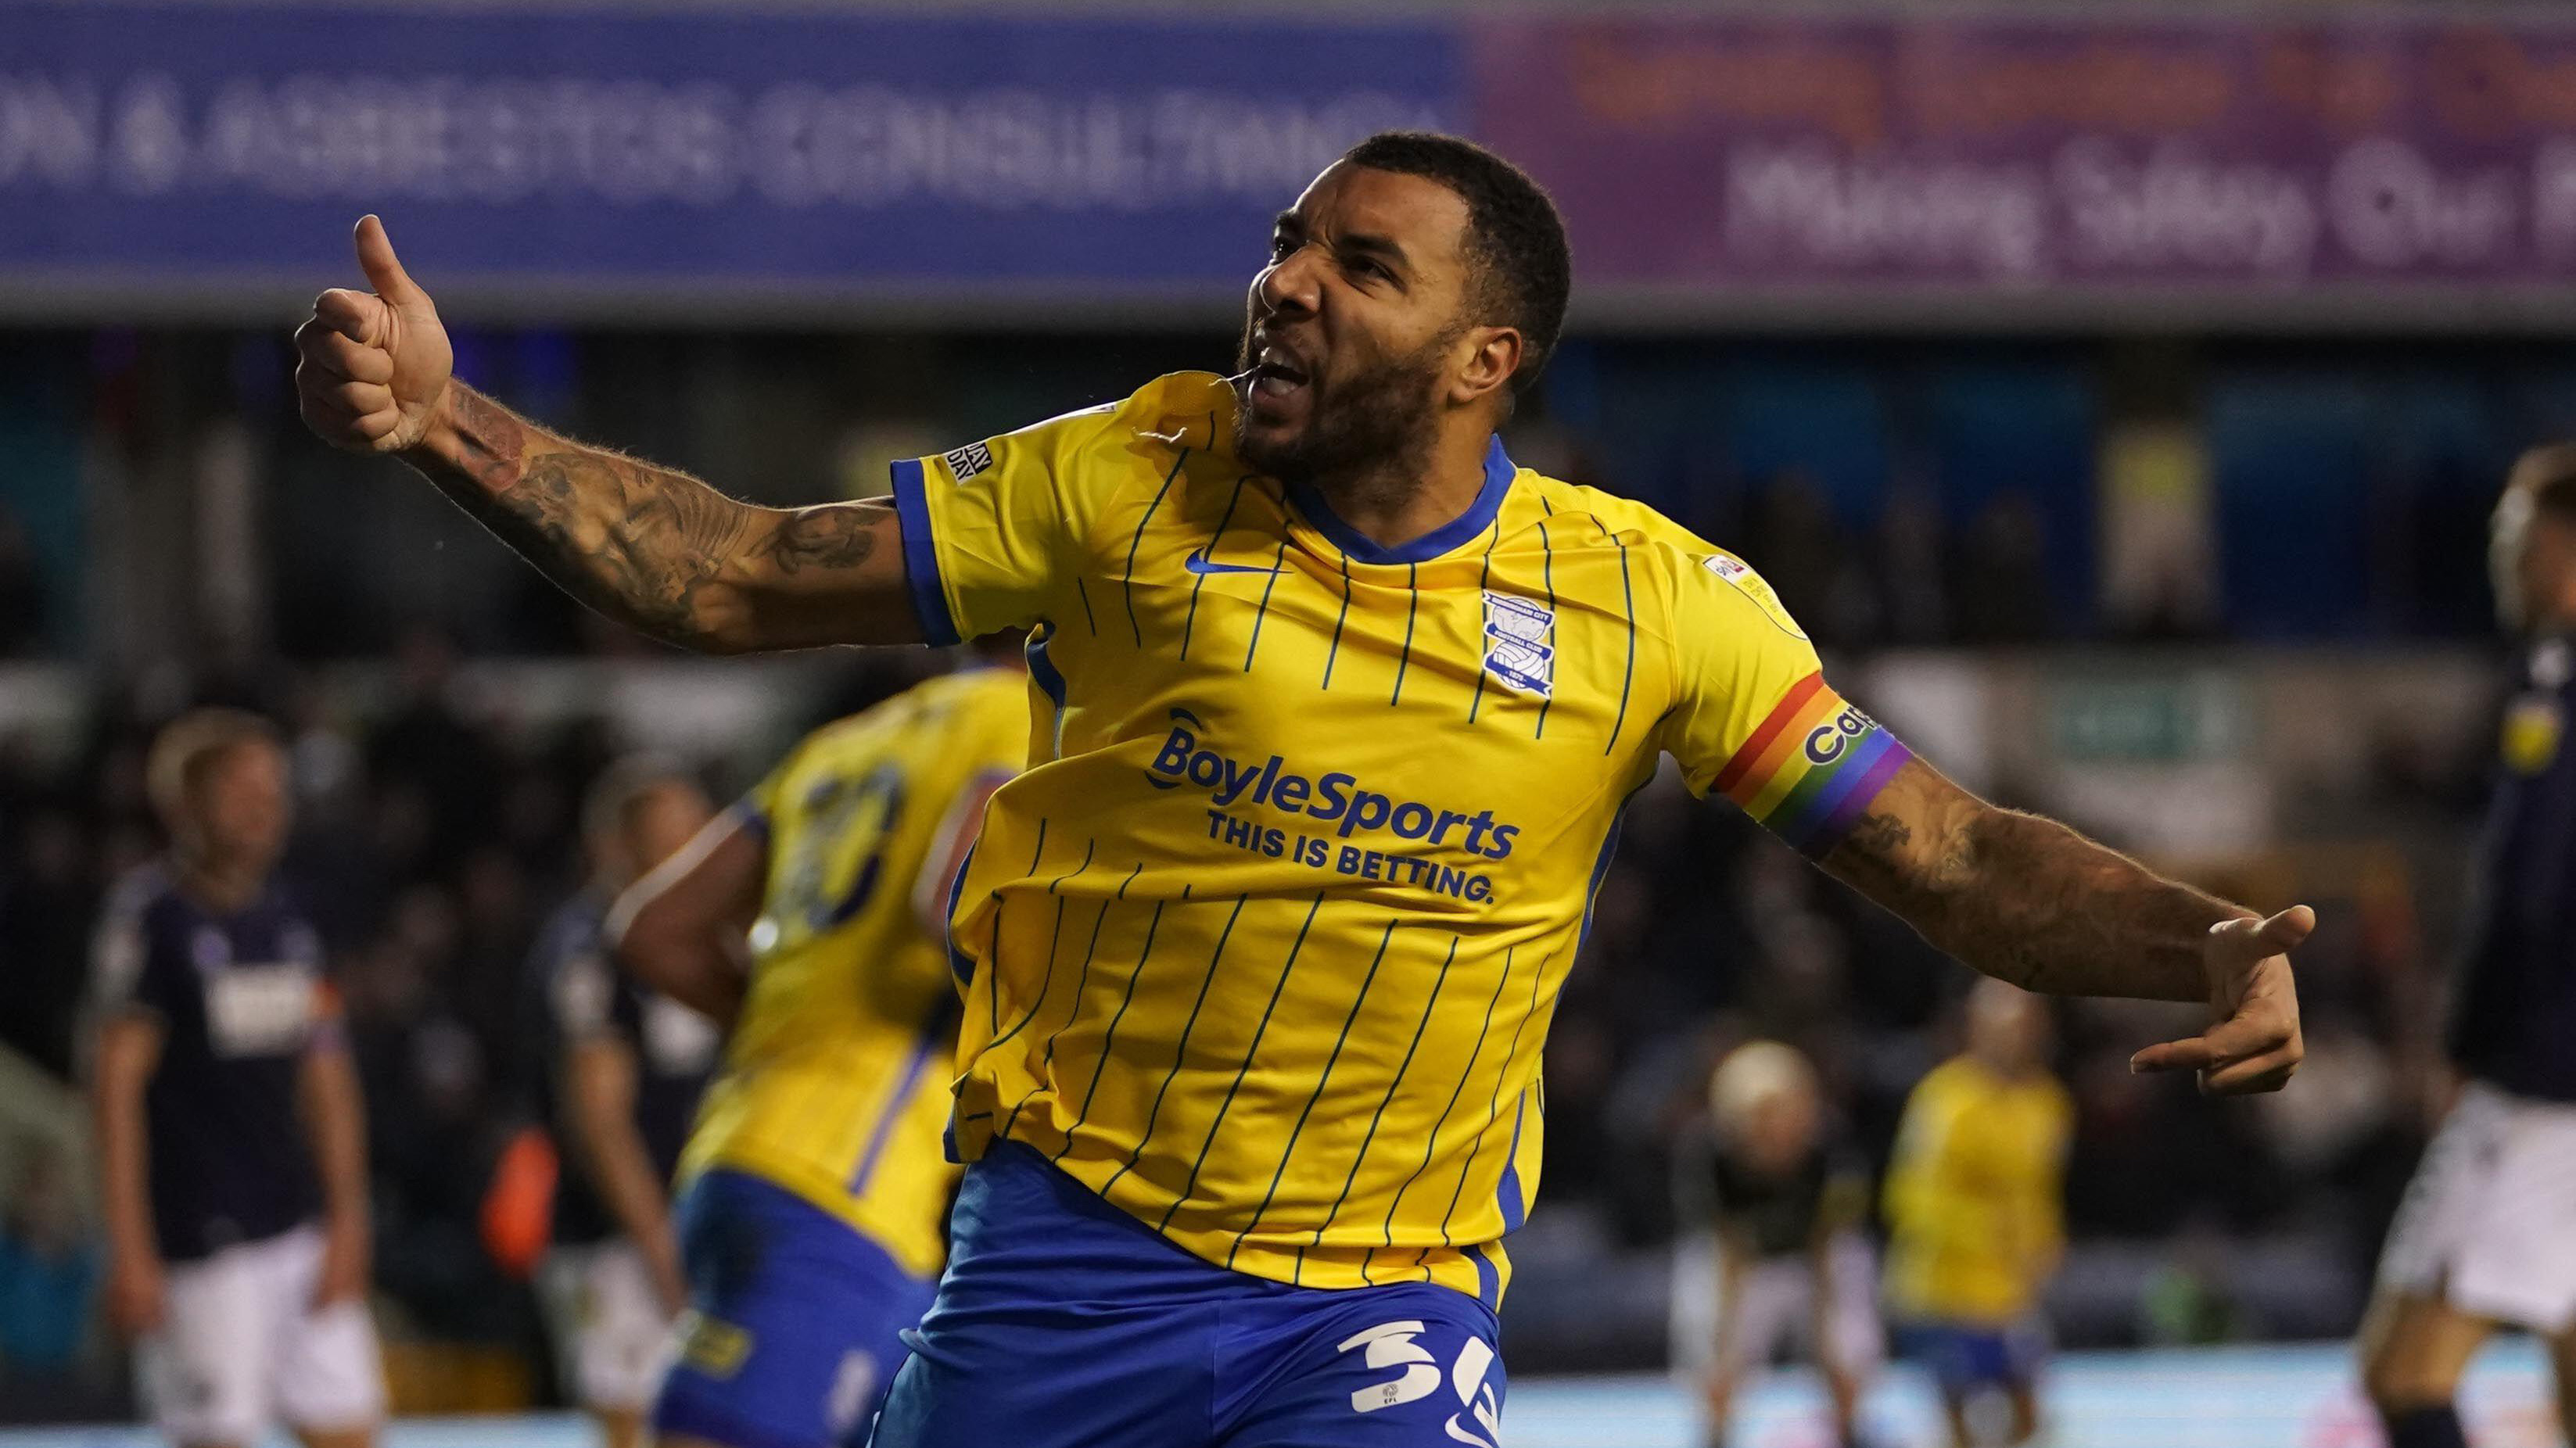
[894,374,1903,1303]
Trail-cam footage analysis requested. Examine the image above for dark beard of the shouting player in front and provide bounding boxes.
[1234,328,1463,487]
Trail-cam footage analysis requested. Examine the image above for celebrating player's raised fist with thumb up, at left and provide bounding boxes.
[296,217,456,453]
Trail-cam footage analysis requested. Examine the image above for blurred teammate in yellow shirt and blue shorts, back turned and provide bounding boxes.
[611,639,1028,1448]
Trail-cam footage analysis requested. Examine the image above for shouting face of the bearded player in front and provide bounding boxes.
[1234,163,1471,482]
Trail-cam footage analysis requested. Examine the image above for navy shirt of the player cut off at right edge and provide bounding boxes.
[2450,639,2576,1100]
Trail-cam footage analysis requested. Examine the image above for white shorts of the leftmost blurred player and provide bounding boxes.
[134,1227,384,1448]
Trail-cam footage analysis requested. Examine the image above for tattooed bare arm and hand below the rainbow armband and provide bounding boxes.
[1824,760,2316,1092]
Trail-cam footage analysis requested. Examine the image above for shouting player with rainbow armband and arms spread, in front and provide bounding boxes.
[299,134,2311,1448]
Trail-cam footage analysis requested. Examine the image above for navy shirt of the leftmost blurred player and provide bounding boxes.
[95,866,338,1260]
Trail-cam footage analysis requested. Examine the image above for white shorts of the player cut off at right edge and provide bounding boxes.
[2380,1082,2576,1332]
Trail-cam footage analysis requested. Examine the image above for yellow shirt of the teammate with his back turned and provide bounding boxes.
[680,668,1028,1275]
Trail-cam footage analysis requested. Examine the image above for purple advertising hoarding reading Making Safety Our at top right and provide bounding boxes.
[1469,18,2576,320]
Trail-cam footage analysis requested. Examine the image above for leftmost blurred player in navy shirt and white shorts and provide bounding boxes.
[90,708,384,1448]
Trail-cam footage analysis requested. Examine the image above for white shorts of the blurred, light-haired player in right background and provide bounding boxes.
[1672,1231,1885,1378]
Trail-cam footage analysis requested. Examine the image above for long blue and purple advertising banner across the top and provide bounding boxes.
[15,2,2576,324]
